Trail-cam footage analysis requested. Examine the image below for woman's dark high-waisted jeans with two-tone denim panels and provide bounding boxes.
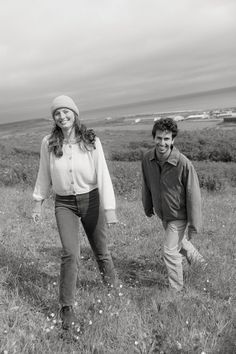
[55,189,115,306]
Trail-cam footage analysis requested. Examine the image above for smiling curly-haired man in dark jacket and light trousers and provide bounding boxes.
[142,118,206,291]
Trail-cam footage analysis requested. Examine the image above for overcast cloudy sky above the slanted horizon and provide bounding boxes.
[0,0,236,123]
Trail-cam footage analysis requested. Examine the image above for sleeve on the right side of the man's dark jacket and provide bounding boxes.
[186,163,202,234]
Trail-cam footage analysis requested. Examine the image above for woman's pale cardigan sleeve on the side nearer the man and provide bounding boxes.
[93,137,117,223]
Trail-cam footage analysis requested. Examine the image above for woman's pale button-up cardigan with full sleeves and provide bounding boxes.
[33,135,116,222]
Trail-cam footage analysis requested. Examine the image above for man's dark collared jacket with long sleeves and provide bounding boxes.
[142,147,202,232]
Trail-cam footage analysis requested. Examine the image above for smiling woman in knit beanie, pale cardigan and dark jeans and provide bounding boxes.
[32,96,117,329]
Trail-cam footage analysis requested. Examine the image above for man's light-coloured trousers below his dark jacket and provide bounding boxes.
[163,220,203,291]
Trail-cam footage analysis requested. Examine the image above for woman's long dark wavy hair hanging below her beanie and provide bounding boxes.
[48,113,96,157]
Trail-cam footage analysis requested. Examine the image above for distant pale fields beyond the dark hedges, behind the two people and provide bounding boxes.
[0,119,221,152]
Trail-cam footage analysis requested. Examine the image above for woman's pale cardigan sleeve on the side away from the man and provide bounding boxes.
[33,136,52,201]
